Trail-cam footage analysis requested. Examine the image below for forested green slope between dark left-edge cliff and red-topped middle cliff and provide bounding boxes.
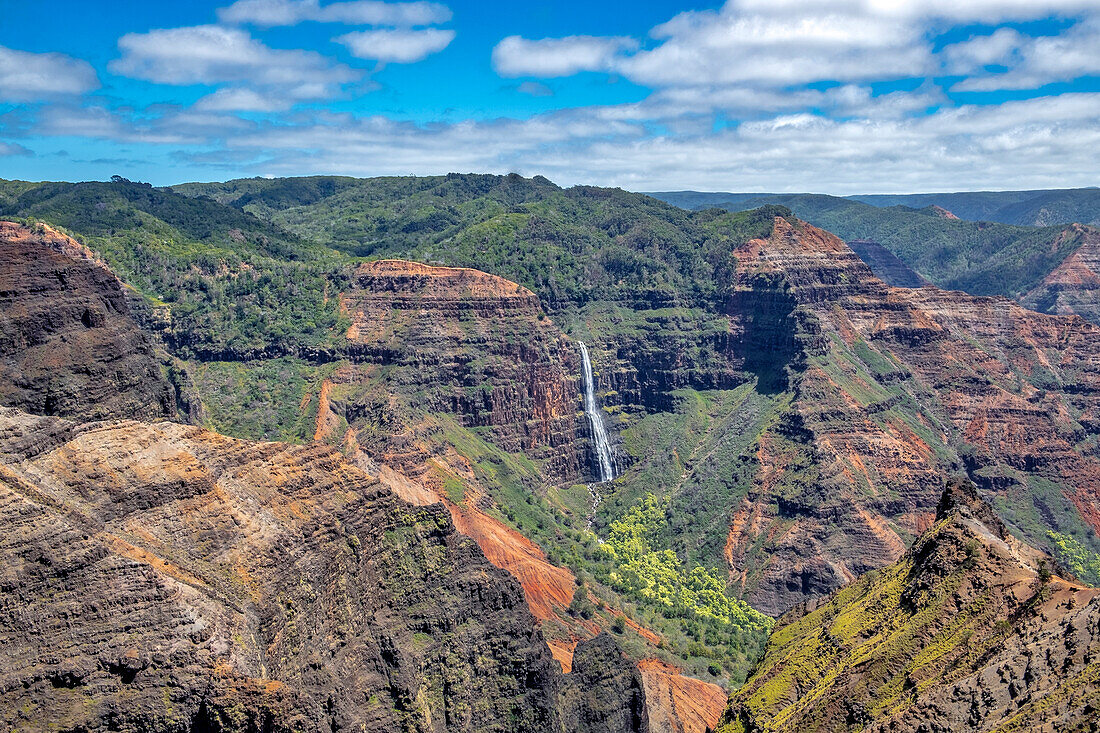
[0,179,348,359]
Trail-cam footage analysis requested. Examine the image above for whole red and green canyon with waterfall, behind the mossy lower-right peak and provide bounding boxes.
[0,175,1100,733]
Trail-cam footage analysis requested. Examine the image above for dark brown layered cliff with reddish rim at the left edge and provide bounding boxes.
[0,221,175,419]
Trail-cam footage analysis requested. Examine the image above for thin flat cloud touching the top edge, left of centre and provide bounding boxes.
[218,0,452,28]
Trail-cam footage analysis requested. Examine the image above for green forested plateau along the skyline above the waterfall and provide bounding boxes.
[175,174,790,309]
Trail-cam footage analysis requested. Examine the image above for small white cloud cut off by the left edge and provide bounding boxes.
[0,46,99,102]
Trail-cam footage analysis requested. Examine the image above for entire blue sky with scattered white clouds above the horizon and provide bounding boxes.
[0,0,1100,194]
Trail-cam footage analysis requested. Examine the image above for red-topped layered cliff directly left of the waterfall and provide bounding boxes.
[328,260,585,479]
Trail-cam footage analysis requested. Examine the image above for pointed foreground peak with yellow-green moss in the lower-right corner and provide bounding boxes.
[719,484,1100,733]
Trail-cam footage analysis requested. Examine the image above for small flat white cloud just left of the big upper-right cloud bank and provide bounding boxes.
[493,35,637,78]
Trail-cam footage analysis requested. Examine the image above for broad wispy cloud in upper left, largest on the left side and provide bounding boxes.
[109,25,360,98]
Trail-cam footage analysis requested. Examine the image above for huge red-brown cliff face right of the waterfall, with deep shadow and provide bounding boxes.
[726,219,1100,612]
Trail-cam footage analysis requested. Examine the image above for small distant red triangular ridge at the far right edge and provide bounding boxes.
[1020,225,1100,324]
